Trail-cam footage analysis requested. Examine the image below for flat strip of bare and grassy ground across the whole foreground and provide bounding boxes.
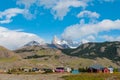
[0,73,120,80]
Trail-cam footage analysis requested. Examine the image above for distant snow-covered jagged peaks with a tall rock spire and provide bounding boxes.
[24,36,81,49]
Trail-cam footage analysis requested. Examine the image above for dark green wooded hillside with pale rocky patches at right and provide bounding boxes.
[62,41,120,65]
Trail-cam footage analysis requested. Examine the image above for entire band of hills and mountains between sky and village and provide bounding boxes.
[0,39,120,68]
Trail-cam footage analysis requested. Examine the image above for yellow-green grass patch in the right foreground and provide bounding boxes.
[63,73,120,80]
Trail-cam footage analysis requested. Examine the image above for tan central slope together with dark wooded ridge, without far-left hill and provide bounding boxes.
[15,42,120,67]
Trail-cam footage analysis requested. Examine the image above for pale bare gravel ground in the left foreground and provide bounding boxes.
[0,74,67,80]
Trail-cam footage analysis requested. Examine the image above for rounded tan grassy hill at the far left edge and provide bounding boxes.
[0,46,21,69]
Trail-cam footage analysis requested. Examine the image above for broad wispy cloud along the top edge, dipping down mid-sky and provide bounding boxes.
[17,0,91,20]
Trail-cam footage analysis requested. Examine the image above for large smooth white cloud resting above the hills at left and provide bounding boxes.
[0,27,43,49]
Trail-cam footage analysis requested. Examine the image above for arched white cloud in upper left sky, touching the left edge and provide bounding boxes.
[0,8,34,24]
